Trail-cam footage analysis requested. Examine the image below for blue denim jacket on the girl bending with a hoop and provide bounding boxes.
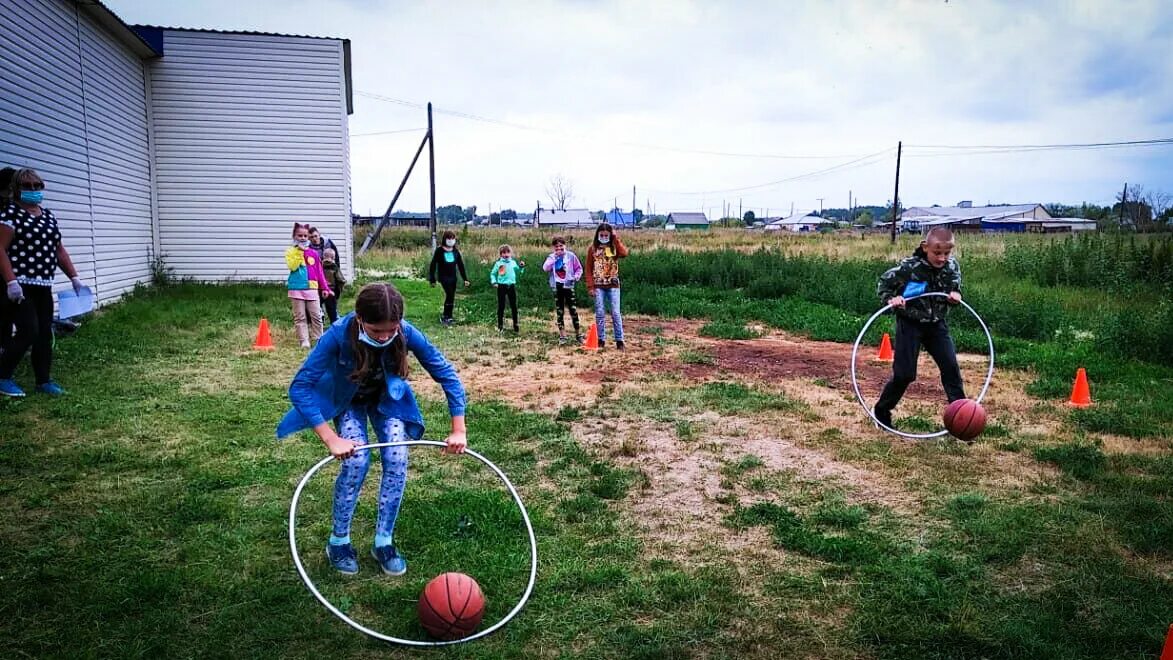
[277,312,465,440]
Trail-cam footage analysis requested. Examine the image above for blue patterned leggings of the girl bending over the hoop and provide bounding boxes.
[333,406,407,537]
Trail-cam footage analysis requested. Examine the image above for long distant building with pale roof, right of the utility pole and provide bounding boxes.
[900,202,1096,233]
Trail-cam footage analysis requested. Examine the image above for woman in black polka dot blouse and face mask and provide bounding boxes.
[0,169,84,396]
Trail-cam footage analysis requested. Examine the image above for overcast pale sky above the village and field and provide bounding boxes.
[106,0,1173,217]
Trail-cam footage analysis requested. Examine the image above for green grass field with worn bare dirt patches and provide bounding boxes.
[0,229,1173,659]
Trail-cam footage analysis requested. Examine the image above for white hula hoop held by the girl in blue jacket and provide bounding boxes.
[290,440,537,646]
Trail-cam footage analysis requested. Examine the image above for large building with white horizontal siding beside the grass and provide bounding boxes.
[0,0,354,302]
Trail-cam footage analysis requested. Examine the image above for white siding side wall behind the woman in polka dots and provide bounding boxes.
[0,0,151,301]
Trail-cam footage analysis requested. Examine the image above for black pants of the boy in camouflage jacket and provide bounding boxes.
[876,317,965,413]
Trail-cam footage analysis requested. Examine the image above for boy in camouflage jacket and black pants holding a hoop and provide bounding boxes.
[874,227,965,429]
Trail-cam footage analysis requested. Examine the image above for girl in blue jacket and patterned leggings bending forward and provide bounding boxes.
[277,283,468,576]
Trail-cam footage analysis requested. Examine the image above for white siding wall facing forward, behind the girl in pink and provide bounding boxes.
[150,30,353,280]
